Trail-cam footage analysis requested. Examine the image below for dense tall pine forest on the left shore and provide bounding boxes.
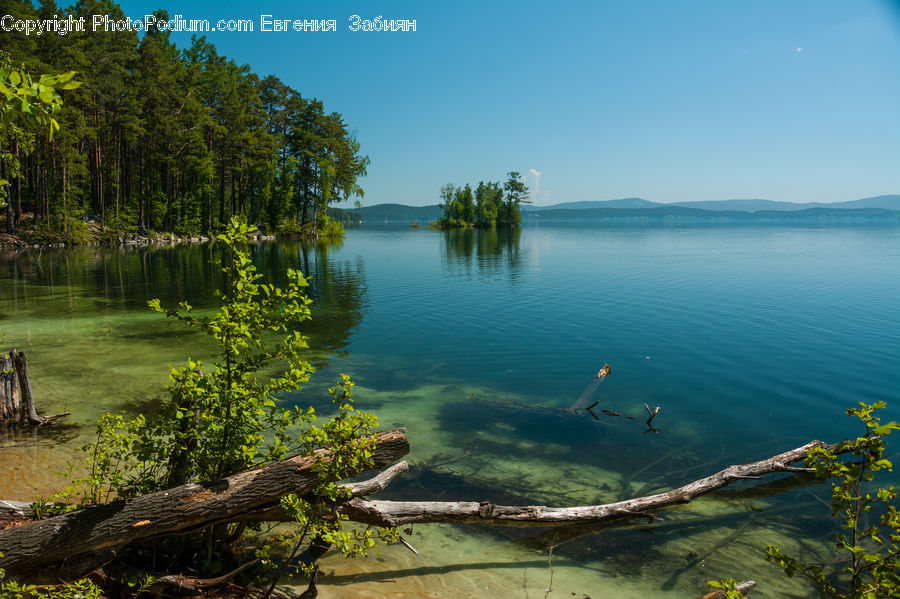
[0,0,369,243]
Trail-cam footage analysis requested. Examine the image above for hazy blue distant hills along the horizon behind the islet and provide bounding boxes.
[333,195,900,223]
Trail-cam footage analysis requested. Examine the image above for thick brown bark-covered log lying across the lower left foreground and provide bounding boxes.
[0,430,409,575]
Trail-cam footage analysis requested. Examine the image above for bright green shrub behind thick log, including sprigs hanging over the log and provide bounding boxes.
[67,219,395,588]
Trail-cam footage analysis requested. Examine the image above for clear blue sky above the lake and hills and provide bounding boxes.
[114,0,900,205]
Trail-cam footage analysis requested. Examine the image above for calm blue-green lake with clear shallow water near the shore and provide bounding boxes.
[0,223,900,599]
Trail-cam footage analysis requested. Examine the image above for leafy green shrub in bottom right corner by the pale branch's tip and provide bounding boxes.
[766,401,900,599]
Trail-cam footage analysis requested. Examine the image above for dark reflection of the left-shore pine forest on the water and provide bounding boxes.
[0,240,366,357]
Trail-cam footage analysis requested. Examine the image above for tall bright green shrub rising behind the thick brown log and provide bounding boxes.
[78,219,315,496]
